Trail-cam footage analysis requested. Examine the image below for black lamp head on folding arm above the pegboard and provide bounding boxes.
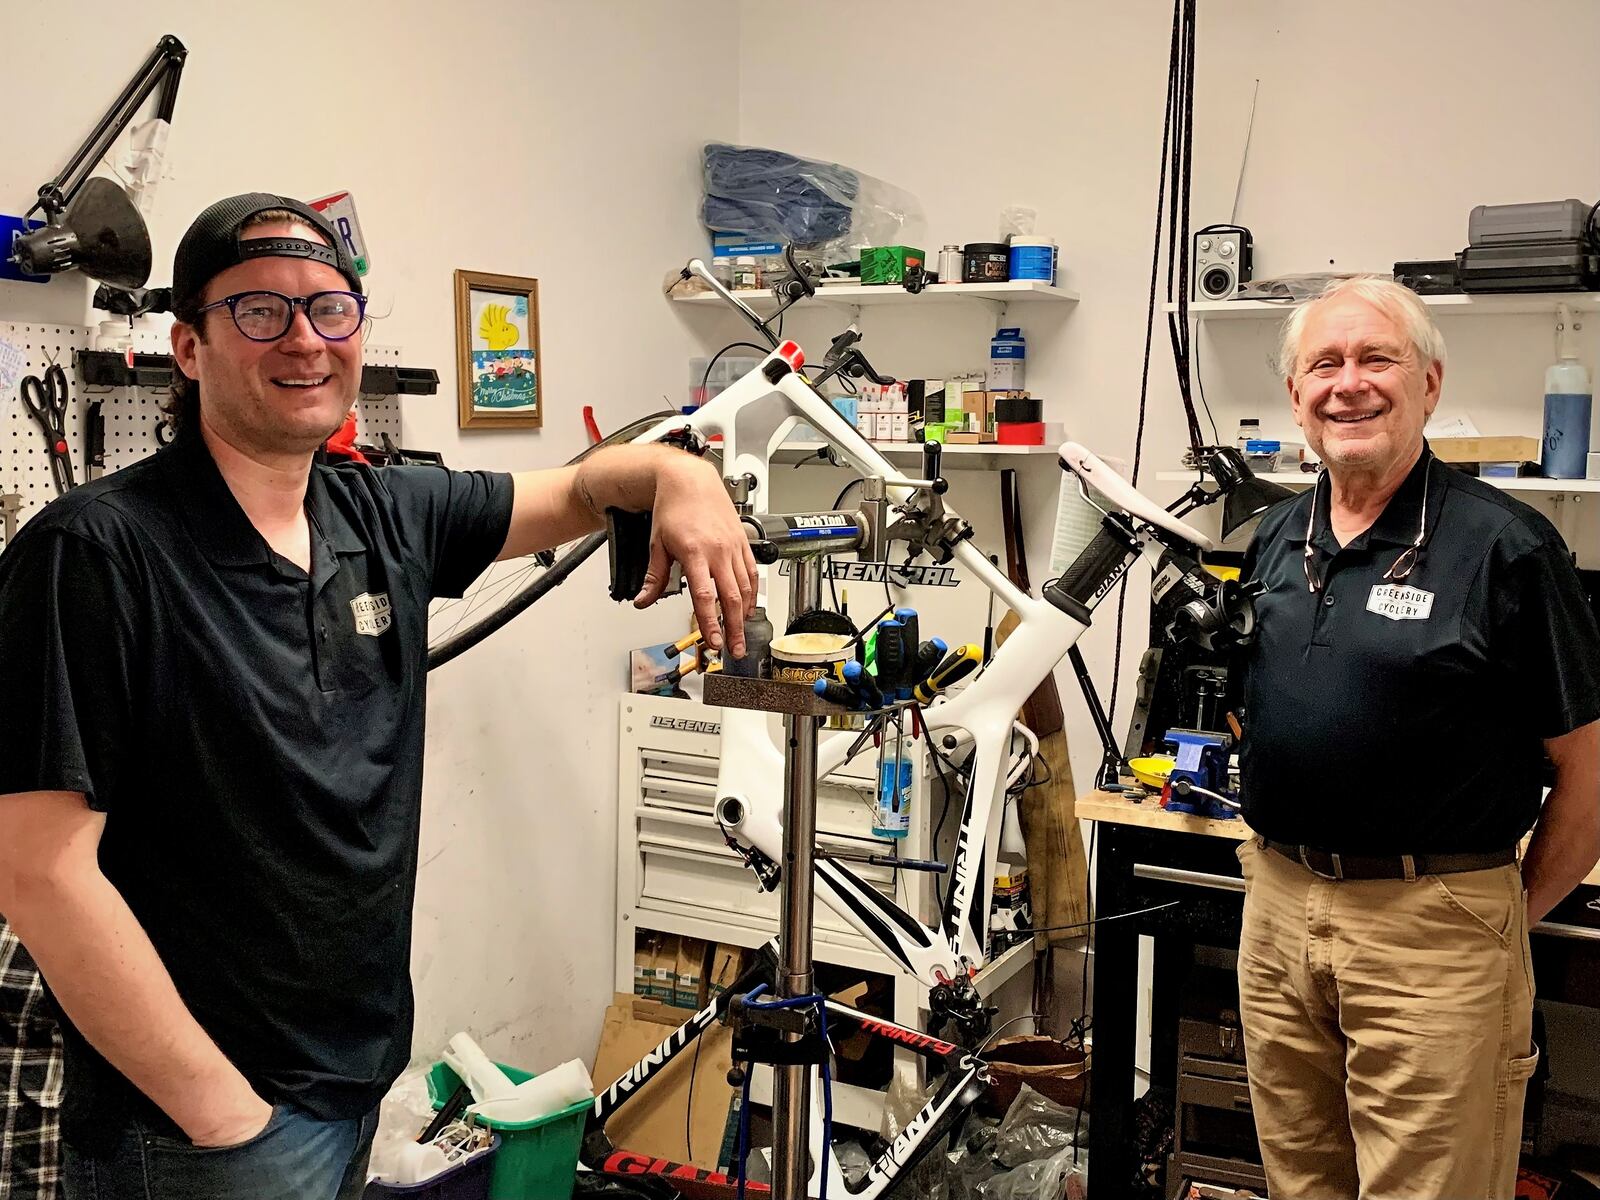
[11,176,150,288]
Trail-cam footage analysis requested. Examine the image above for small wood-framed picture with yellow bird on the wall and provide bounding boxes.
[456,270,544,429]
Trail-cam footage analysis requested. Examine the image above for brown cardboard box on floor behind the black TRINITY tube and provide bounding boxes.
[594,992,734,1170]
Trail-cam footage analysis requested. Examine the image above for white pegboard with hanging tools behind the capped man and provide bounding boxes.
[0,323,403,544]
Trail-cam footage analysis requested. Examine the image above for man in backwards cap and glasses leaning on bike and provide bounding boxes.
[0,194,755,1200]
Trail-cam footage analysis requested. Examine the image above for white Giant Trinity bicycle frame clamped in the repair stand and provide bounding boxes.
[594,307,1211,1200]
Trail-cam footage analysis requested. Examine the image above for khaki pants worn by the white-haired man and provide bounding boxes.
[1238,840,1538,1200]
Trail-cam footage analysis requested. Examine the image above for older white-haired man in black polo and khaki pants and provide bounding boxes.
[1238,277,1600,1200]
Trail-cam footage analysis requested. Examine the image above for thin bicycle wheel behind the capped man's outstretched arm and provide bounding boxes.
[427,410,675,670]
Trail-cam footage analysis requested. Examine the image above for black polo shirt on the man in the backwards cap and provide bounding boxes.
[0,434,512,1152]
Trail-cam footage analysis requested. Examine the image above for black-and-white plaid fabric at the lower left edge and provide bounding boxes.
[0,918,61,1200]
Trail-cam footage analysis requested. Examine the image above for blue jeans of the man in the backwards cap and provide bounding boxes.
[62,1104,378,1200]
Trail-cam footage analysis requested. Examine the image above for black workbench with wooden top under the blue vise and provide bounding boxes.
[1078,792,1600,1200]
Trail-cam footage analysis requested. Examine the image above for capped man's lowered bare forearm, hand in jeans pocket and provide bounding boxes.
[6,874,261,1141]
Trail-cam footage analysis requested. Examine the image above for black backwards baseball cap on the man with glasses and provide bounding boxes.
[171,192,362,320]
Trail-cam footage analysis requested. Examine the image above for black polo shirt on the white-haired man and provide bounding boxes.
[1240,446,1600,854]
